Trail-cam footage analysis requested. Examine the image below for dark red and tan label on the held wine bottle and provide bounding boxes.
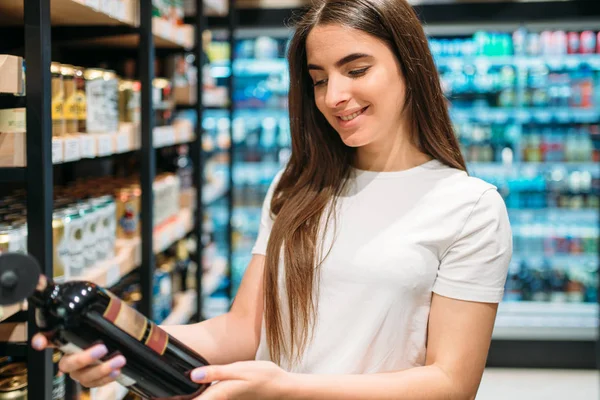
[103,291,169,355]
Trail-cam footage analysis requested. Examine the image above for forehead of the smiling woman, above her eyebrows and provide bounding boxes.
[306,25,392,65]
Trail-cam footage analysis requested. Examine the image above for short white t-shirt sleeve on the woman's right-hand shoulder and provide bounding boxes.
[433,189,512,303]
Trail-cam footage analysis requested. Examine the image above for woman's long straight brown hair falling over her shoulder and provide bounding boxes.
[264,0,466,363]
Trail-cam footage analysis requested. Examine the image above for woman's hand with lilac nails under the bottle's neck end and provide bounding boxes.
[31,333,126,388]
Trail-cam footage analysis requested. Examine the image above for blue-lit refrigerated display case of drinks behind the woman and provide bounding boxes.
[203,12,600,367]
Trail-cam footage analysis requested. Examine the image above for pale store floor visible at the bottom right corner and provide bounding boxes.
[477,368,600,400]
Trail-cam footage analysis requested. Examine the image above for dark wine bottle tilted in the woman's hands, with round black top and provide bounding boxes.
[0,253,208,400]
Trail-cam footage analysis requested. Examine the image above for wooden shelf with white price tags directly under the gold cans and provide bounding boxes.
[0,120,194,168]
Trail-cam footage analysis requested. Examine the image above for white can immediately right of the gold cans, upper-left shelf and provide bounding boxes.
[80,69,106,133]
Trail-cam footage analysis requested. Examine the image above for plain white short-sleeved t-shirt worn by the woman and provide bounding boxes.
[252,160,512,374]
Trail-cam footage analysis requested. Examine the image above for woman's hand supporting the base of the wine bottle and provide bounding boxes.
[191,361,289,400]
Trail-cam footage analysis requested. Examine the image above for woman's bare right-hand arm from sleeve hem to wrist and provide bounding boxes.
[280,294,497,400]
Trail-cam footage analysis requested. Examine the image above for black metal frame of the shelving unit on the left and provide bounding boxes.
[0,0,213,400]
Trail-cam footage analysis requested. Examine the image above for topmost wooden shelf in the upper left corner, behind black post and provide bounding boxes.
[0,0,137,26]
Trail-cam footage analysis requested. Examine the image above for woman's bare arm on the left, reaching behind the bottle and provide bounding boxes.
[161,255,265,365]
